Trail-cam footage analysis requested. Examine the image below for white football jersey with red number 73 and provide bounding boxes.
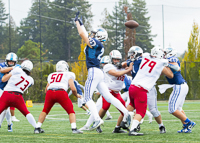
[4,67,34,93]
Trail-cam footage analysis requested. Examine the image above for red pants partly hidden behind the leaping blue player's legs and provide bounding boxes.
[102,91,126,116]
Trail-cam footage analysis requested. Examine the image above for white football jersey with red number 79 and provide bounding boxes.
[131,53,168,91]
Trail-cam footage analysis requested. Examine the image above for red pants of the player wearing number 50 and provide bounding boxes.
[42,90,75,114]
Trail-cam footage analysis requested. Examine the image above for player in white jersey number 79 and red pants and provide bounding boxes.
[129,47,177,136]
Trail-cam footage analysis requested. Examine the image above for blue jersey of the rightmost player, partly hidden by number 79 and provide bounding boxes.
[166,56,185,84]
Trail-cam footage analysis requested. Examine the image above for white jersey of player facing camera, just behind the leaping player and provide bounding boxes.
[103,64,125,91]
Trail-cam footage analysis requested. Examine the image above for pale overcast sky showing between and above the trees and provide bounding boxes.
[3,0,200,54]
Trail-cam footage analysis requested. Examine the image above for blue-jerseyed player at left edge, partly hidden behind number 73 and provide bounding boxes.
[0,52,17,132]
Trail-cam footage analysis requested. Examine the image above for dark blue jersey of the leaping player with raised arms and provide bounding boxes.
[84,38,104,69]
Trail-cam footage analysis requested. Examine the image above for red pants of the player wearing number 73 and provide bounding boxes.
[0,91,30,117]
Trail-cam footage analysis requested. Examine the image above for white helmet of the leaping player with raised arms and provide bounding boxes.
[91,28,108,42]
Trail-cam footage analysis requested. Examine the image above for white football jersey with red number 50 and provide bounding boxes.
[47,72,75,91]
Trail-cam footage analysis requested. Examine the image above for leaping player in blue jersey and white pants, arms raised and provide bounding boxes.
[75,12,131,130]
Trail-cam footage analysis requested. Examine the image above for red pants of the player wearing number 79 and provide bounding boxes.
[129,84,148,118]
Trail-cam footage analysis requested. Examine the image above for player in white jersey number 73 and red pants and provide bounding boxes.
[0,60,36,131]
